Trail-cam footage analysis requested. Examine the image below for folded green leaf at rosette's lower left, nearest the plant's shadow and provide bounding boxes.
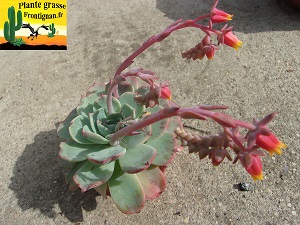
[73,161,115,192]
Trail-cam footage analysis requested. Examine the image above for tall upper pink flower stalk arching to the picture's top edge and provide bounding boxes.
[107,0,242,113]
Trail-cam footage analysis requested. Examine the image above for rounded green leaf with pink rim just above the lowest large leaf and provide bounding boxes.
[119,144,156,173]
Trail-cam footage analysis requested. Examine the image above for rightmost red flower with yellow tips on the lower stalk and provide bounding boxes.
[256,133,287,156]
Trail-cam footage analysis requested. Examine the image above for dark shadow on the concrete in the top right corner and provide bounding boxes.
[156,0,300,33]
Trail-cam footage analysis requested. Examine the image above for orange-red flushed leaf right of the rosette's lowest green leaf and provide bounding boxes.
[136,165,167,199]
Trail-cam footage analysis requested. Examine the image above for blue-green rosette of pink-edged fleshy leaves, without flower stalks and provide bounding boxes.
[58,82,181,214]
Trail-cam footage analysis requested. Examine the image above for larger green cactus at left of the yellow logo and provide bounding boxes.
[4,6,22,44]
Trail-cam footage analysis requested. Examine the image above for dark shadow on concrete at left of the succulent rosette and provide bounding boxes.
[9,130,99,222]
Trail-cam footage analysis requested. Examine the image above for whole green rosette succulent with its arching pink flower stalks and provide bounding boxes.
[58,0,286,214]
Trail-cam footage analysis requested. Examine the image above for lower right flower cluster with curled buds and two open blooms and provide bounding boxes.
[175,110,286,180]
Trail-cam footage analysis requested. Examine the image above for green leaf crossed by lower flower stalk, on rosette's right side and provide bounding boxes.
[147,105,169,141]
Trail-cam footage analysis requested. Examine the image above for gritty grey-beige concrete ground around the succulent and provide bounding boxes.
[0,0,300,225]
